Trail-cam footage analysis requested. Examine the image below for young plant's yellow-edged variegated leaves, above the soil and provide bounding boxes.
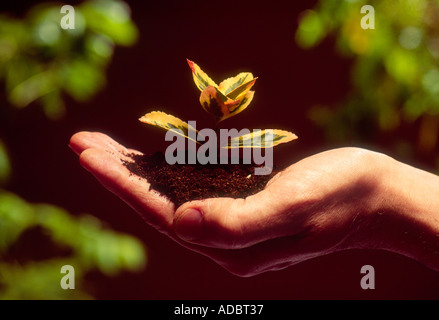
[139,60,297,149]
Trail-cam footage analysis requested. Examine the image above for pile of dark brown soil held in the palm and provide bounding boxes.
[125,152,275,206]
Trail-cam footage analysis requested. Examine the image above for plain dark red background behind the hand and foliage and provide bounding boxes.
[2,0,439,299]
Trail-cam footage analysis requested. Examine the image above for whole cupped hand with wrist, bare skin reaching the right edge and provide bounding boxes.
[69,132,439,276]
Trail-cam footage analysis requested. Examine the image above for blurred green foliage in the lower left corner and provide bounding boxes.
[0,190,146,299]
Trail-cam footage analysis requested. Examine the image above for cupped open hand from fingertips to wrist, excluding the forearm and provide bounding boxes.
[70,132,388,276]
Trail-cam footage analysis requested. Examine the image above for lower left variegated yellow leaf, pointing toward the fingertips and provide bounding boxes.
[139,111,199,144]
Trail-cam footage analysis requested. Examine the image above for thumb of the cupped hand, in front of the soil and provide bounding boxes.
[173,189,294,249]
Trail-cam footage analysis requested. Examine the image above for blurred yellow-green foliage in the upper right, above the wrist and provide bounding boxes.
[296,0,439,165]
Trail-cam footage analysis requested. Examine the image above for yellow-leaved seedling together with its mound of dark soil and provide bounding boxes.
[125,60,297,202]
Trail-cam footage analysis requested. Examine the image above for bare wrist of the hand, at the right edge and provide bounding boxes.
[354,155,439,270]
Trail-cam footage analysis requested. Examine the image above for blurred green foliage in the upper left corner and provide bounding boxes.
[0,0,138,118]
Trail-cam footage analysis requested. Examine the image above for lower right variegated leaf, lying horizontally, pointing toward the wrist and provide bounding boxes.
[221,129,297,149]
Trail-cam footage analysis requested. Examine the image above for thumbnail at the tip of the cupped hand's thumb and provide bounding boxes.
[175,208,203,241]
